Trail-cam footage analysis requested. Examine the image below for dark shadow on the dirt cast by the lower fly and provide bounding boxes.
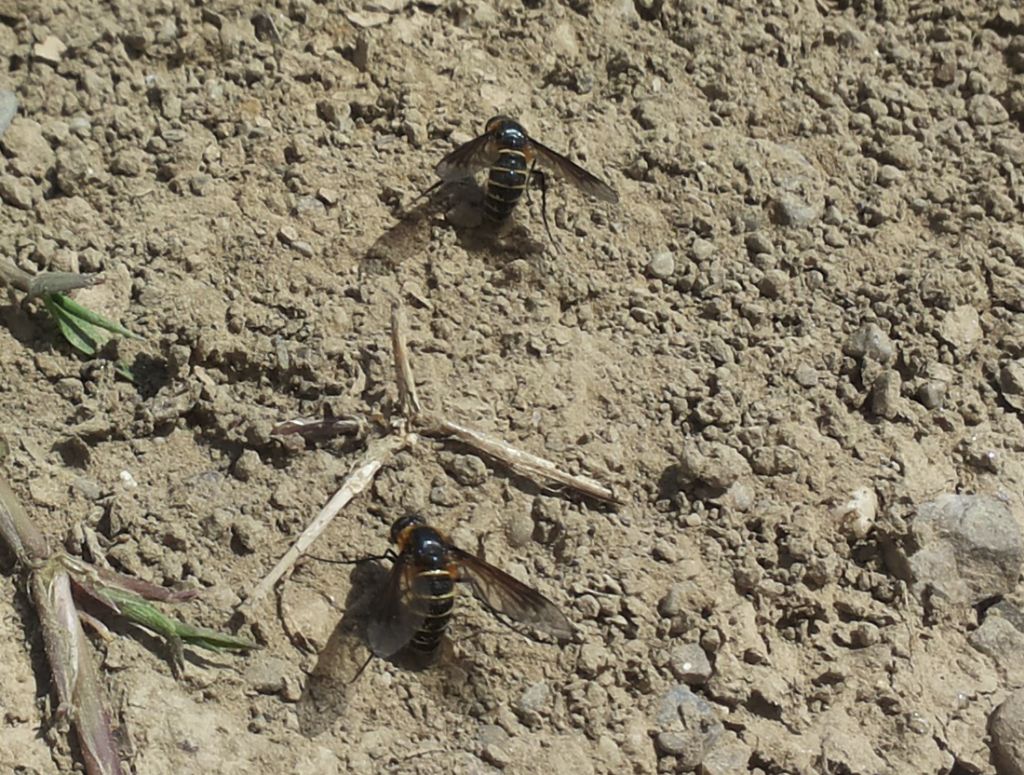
[296,562,486,738]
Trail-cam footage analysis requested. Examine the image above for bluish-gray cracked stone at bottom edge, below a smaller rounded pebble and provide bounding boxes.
[654,685,725,772]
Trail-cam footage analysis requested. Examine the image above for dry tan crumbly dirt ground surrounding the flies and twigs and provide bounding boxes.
[0,0,1024,775]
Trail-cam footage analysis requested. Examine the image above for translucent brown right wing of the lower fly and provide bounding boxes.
[449,547,572,640]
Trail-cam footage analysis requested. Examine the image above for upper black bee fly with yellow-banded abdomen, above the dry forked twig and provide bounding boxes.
[437,116,618,243]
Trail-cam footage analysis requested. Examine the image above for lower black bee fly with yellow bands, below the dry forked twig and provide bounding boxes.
[358,516,572,658]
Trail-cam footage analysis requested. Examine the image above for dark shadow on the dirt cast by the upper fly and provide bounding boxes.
[359,177,546,276]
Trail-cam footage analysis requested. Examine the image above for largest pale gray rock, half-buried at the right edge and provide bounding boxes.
[891,496,1024,605]
